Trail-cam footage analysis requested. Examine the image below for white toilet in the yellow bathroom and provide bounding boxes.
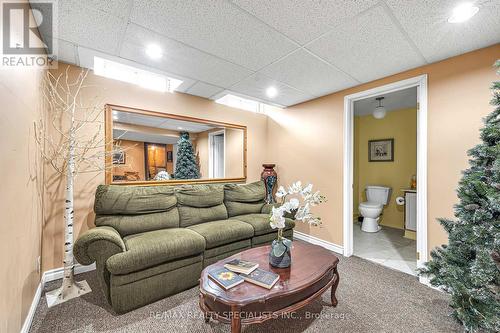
[359,186,391,232]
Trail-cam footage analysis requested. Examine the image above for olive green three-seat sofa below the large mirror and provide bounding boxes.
[73,182,295,313]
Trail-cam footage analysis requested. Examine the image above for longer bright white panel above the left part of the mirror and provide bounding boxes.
[94,57,182,92]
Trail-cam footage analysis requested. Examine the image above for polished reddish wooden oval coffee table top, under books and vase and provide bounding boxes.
[200,241,339,306]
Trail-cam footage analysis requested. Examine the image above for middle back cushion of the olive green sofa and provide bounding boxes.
[175,184,228,227]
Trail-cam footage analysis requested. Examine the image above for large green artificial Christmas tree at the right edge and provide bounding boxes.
[420,61,500,332]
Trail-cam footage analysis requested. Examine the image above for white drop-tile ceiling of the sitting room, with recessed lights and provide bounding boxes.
[42,0,500,106]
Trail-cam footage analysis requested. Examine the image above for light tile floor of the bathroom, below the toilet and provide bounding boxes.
[353,222,417,275]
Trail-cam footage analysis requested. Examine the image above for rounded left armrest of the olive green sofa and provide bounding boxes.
[73,226,127,265]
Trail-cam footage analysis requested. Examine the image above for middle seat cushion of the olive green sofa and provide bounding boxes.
[187,219,254,249]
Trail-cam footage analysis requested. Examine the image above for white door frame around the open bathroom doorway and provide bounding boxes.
[343,74,427,281]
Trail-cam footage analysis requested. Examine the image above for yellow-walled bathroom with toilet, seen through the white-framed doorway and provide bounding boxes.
[353,87,418,275]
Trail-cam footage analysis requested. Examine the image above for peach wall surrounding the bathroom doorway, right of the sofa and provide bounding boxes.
[267,44,500,253]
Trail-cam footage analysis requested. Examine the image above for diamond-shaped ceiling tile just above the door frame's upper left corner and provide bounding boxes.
[260,49,359,96]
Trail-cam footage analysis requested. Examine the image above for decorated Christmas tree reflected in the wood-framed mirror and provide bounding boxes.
[174,132,200,179]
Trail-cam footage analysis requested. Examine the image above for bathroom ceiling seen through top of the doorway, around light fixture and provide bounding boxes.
[354,87,417,116]
